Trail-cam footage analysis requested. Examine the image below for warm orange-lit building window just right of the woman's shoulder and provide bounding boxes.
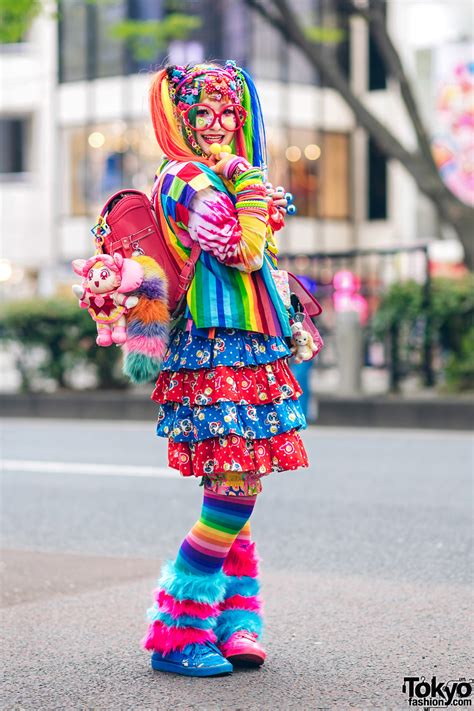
[268,129,350,220]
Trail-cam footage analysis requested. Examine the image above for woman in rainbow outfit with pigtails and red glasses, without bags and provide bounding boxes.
[144,62,307,676]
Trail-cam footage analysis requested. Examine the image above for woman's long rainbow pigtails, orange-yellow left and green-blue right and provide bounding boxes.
[150,63,266,169]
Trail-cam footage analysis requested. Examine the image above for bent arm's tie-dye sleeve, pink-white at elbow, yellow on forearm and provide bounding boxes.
[188,168,268,272]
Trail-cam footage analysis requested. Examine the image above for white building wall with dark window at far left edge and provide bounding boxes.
[0,6,59,296]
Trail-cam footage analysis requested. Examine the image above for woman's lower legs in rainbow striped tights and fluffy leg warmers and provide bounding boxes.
[144,490,262,654]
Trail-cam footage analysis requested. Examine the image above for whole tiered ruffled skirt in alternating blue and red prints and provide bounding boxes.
[152,329,308,495]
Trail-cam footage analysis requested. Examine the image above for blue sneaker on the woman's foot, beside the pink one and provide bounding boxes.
[151,642,234,676]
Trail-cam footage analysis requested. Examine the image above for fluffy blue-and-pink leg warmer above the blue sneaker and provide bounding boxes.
[143,562,226,654]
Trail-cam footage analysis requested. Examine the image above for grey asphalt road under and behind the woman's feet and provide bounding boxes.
[0,420,473,711]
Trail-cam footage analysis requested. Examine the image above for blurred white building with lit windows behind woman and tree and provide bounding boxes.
[0,0,468,293]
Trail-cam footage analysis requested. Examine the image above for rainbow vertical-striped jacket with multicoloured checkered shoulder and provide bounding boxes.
[154,161,291,336]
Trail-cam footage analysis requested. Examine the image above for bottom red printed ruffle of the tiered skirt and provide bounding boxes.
[168,430,308,479]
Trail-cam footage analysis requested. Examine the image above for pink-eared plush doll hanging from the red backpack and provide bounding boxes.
[72,254,144,346]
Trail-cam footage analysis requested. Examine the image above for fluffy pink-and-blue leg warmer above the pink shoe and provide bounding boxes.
[215,537,263,644]
